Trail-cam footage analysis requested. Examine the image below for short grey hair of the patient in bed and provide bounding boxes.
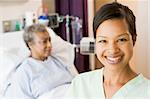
[23,24,48,50]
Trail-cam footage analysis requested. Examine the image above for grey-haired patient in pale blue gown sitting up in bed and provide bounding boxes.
[4,24,74,99]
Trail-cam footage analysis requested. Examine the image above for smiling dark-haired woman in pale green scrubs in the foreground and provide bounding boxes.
[67,2,150,99]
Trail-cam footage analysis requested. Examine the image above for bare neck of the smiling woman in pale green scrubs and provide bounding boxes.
[104,65,137,85]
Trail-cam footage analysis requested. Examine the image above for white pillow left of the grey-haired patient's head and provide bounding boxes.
[0,31,30,60]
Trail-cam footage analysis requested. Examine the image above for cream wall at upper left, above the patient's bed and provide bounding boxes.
[0,0,42,33]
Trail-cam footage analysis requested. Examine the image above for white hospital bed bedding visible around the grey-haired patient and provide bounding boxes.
[0,28,78,99]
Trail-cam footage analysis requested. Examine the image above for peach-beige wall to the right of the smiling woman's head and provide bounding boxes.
[89,0,150,78]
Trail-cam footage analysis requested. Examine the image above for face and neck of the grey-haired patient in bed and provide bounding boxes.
[30,32,52,60]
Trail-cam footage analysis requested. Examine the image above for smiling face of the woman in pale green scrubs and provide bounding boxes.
[96,19,133,69]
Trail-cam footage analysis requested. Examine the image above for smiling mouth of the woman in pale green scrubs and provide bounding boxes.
[105,56,122,64]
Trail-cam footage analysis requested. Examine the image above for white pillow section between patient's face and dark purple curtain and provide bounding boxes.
[47,28,78,75]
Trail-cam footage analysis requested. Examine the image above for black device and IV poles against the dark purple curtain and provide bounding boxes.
[48,13,82,44]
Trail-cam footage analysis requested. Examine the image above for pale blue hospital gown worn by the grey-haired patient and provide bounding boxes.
[4,57,73,99]
